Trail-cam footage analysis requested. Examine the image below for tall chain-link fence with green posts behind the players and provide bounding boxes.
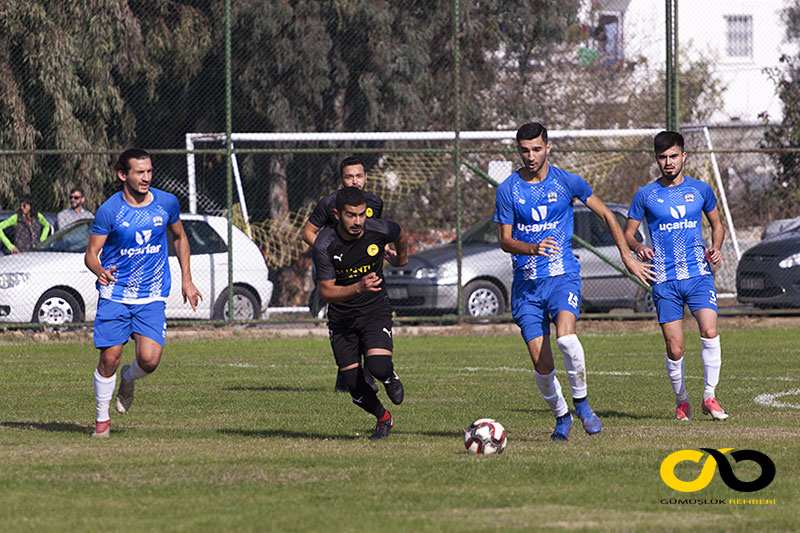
[0,0,800,324]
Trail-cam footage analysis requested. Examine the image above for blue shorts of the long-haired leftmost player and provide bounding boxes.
[94,298,167,348]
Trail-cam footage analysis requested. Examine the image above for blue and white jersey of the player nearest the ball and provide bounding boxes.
[494,165,592,280]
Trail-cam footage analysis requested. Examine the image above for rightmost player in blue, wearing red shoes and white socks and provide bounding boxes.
[625,131,728,420]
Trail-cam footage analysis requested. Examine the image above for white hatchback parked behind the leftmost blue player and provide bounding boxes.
[0,214,273,325]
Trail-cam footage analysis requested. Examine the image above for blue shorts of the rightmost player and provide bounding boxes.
[653,276,717,324]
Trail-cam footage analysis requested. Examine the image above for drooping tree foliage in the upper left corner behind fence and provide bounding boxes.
[0,0,210,212]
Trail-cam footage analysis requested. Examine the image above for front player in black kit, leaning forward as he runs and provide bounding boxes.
[314,187,408,440]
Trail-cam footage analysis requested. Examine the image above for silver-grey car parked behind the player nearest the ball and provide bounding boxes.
[384,204,655,317]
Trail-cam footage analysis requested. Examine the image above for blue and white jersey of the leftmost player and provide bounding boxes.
[92,188,180,304]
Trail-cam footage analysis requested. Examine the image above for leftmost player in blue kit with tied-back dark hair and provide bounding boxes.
[84,148,202,437]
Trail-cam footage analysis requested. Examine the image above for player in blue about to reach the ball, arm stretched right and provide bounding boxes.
[494,122,652,440]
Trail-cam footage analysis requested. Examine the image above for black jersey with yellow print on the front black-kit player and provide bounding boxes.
[314,218,400,321]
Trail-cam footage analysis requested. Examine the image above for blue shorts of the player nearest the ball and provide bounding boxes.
[511,272,581,343]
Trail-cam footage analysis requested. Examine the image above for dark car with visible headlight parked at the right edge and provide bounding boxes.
[736,225,800,307]
